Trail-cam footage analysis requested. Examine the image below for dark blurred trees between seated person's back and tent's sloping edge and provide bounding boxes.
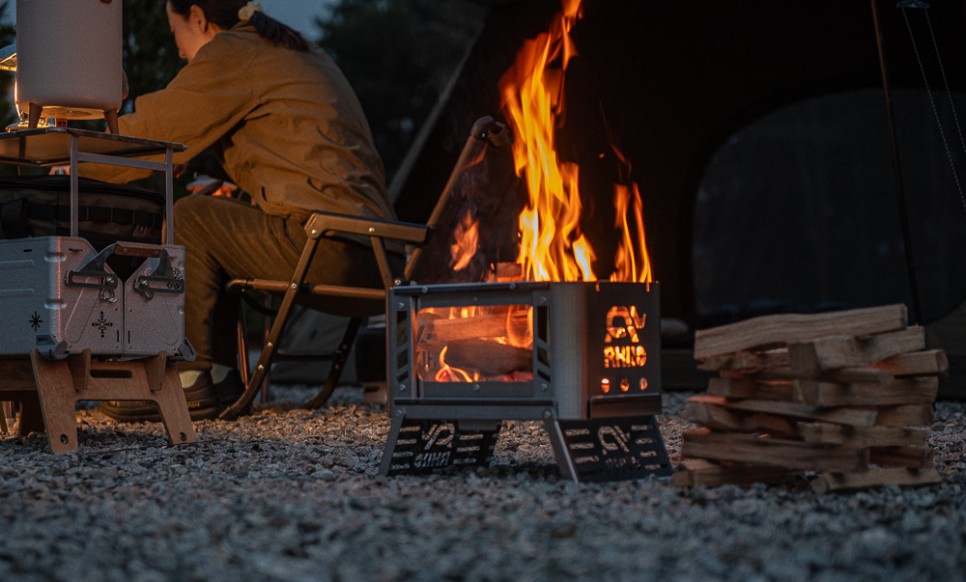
[316,0,486,178]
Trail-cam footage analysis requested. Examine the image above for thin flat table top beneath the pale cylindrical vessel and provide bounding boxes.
[0,127,187,166]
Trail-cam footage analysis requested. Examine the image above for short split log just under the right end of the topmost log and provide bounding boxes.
[788,326,926,374]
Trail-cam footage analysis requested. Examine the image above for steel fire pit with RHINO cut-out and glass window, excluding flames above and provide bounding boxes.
[381,282,671,481]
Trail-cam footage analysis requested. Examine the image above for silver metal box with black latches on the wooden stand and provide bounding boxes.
[0,236,191,358]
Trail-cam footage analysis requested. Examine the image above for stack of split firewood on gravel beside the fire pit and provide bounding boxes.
[674,305,948,491]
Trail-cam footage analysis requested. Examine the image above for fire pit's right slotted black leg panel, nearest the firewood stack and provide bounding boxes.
[544,416,673,482]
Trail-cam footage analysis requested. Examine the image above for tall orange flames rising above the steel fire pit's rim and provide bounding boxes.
[500,0,651,282]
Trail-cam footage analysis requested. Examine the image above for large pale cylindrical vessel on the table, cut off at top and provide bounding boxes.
[17,0,123,119]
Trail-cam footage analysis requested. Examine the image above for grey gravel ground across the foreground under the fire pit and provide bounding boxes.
[0,388,966,582]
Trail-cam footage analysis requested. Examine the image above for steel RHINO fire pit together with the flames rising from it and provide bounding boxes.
[382,0,671,481]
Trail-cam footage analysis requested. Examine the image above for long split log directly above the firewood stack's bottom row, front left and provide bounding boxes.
[681,429,869,473]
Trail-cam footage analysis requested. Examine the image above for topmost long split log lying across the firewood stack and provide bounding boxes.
[694,304,908,360]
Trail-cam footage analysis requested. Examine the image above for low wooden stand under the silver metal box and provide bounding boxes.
[0,350,195,453]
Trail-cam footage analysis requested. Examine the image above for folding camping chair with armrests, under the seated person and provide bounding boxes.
[219,117,512,420]
